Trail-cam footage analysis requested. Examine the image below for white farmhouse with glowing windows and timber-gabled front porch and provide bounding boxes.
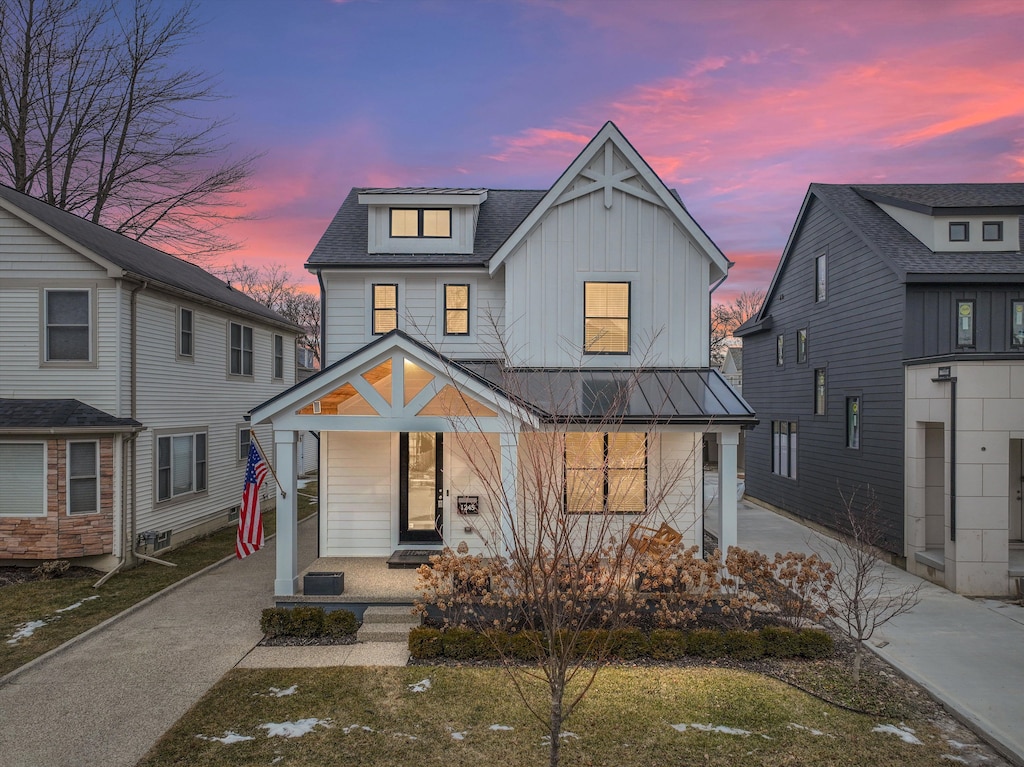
[252,123,756,596]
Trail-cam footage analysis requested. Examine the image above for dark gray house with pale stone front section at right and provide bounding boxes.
[736,183,1024,595]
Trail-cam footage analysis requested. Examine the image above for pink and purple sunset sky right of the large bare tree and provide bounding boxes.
[181,0,1024,298]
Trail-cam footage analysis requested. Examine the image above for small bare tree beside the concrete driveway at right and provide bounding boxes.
[821,489,922,684]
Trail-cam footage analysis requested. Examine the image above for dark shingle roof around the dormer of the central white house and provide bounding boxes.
[306,188,547,268]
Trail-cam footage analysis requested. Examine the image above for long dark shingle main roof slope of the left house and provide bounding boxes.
[0,184,298,330]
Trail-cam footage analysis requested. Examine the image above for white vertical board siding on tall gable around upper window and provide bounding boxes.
[504,181,710,367]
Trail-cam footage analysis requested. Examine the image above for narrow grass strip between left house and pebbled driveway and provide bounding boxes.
[0,482,316,676]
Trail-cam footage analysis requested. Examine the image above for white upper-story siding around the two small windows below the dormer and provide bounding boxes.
[324,268,505,365]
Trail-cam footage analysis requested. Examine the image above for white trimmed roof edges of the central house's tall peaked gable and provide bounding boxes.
[489,121,730,281]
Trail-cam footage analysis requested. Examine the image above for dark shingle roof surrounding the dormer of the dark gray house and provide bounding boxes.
[810,183,1024,280]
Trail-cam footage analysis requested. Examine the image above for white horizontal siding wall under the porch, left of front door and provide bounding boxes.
[319,431,398,557]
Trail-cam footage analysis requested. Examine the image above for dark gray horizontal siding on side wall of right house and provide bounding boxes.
[743,191,904,555]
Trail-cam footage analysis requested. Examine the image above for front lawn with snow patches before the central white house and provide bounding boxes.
[140,667,974,767]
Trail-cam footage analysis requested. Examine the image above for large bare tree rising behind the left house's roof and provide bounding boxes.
[0,0,255,260]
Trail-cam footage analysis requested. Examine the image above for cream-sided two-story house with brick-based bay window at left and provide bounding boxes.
[0,186,299,569]
